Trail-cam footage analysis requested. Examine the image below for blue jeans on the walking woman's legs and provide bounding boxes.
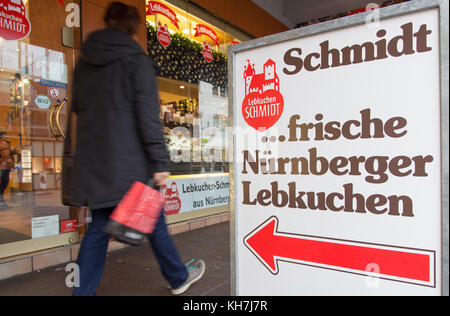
[73,208,188,296]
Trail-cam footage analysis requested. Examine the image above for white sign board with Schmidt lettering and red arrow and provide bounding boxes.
[233,9,442,296]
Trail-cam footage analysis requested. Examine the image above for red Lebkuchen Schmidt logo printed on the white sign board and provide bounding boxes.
[242,59,284,132]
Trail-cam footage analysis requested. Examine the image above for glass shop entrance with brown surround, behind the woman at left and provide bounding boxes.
[0,0,147,262]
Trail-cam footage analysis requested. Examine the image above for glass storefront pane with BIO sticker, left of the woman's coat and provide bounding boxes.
[0,0,76,254]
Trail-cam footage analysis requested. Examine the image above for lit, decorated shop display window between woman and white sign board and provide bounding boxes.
[147,1,240,215]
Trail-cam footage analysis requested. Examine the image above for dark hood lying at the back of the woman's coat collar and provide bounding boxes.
[81,29,144,66]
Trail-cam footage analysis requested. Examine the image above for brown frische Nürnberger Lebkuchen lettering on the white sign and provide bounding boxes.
[241,109,434,217]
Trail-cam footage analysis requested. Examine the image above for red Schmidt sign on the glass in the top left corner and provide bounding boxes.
[0,0,31,41]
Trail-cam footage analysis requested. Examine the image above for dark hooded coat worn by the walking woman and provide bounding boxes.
[63,29,168,210]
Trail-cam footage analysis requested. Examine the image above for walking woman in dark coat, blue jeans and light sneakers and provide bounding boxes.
[63,2,205,296]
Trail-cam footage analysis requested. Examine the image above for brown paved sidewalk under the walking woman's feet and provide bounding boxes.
[0,222,230,296]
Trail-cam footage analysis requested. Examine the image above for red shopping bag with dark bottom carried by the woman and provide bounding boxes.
[104,182,164,246]
